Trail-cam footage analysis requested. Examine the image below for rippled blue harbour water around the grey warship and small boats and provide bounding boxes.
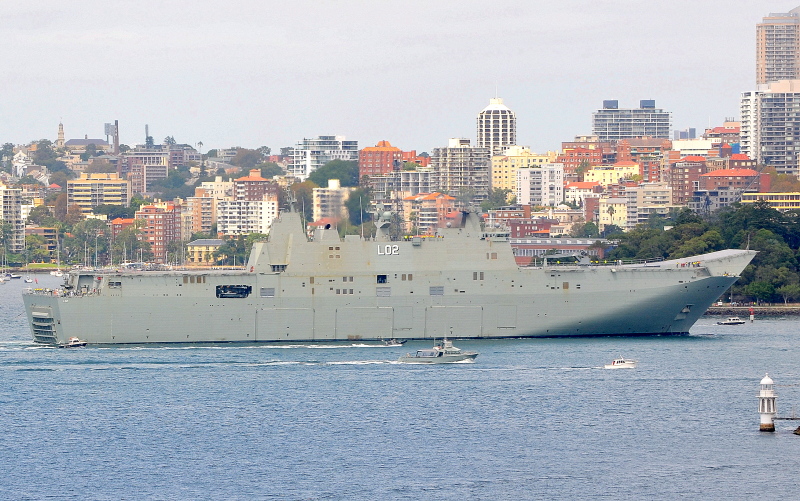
[0,276,800,500]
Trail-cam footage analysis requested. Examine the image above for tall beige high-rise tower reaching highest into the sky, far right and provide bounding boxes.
[756,7,800,84]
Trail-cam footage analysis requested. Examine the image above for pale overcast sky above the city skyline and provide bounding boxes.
[0,0,800,152]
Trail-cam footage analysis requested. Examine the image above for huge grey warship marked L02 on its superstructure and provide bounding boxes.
[23,212,755,345]
